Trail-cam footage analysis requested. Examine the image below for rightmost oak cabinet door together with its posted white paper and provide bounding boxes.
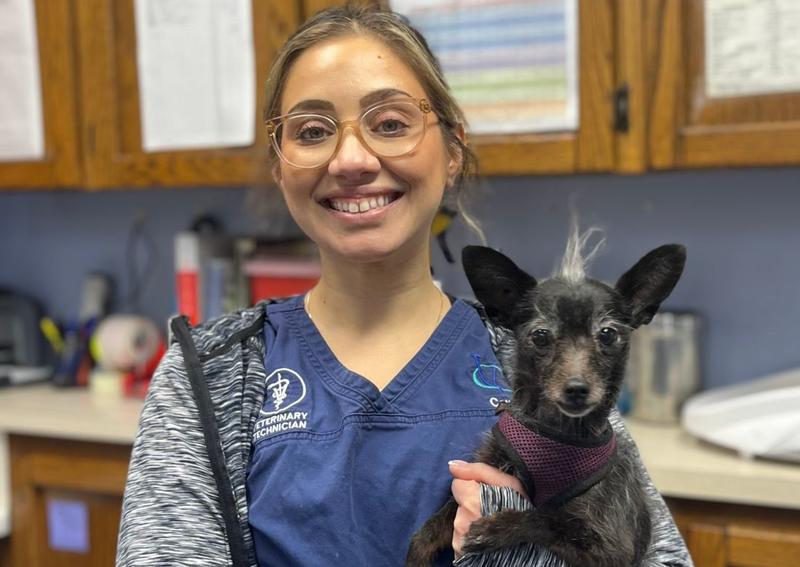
[638,0,800,169]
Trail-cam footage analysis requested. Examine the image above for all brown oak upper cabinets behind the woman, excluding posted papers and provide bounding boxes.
[0,0,800,189]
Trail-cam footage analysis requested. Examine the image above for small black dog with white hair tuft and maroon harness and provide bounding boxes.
[406,233,686,567]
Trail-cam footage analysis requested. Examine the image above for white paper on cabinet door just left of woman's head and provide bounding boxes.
[135,0,256,151]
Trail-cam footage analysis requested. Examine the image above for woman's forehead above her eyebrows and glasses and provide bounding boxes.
[281,35,426,113]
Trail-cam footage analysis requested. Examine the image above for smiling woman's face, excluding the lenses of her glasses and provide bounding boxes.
[274,35,460,262]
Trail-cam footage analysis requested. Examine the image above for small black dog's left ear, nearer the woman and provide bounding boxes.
[461,246,536,328]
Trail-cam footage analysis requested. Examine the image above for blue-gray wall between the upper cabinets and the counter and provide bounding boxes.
[0,168,800,387]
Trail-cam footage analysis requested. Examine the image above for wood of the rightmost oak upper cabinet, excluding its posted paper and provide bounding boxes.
[620,0,800,169]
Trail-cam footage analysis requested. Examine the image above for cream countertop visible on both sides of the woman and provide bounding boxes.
[0,385,800,537]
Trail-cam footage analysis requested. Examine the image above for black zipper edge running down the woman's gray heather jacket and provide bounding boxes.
[170,317,250,567]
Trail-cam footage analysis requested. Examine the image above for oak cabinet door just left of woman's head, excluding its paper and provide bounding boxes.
[76,0,300,188]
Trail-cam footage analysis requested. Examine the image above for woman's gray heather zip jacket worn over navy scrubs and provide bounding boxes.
[117,304,691,567]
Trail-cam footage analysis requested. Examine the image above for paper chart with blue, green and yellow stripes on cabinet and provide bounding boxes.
[391,0,579,134]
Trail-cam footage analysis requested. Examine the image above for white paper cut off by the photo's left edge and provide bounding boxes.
[0,0,44,161]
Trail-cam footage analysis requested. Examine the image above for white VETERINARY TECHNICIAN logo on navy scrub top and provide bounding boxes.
[253,368,308,442]
